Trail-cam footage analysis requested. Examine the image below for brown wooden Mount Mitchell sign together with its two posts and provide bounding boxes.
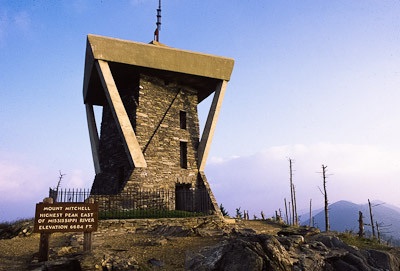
[33,198,99,262]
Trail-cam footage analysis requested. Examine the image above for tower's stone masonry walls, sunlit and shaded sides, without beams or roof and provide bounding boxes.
[92,71,218,216]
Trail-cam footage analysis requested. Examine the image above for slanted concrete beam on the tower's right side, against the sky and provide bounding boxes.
[198,80,228,172]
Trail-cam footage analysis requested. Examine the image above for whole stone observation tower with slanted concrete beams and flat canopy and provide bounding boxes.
[83,35,234,215]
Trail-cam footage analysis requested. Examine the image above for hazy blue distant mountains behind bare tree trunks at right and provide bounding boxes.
[301,200,400,245]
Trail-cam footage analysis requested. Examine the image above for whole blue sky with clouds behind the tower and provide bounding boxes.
[0,0,400,221]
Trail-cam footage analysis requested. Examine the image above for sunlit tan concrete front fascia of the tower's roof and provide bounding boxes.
[87,35,234,81]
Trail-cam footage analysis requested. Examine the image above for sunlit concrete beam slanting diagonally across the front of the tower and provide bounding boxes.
[96,60,147,168]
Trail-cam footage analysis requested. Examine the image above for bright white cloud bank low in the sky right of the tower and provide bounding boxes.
[206,143,400,219]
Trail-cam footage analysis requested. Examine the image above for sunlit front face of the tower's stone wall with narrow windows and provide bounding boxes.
[125,74,199,189]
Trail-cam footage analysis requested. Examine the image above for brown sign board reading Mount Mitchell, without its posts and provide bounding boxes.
[33,202,99,233]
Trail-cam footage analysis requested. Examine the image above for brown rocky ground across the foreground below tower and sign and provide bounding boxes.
[0,219,400,271]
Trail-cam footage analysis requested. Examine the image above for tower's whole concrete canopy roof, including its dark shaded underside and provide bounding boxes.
[83,35,234,105]
